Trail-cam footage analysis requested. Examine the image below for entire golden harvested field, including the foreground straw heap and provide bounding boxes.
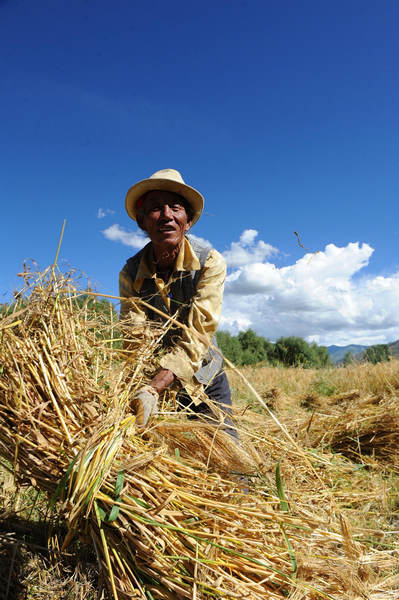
[0,269,399,600]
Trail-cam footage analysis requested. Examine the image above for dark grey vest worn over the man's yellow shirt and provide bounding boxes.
[125,235,223,385]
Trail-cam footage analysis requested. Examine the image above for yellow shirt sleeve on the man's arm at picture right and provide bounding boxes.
[159,250,226,386]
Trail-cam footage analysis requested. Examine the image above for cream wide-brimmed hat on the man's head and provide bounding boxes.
[125,169,204,224]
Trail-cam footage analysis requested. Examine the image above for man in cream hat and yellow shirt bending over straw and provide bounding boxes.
[119,169,237,437]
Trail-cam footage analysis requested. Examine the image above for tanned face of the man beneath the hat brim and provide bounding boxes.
[142,190,191,250]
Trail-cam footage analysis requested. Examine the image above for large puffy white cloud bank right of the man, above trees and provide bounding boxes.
[220,230,399,345]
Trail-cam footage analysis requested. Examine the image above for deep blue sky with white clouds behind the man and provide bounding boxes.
[0,0,399,344]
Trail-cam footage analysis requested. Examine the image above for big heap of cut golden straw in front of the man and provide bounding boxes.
[0,269,397,600]
